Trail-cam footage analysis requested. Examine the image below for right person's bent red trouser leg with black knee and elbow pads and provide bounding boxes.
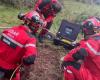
[62,48,97,80]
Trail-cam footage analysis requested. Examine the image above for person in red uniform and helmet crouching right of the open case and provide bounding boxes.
[62,17,100,80]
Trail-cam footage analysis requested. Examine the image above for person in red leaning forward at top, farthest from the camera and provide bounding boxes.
[18,0,62,43]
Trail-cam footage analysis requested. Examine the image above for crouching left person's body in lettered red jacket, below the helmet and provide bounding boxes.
[0,10,37,80]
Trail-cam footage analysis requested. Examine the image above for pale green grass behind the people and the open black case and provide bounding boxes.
[0,0,100,32]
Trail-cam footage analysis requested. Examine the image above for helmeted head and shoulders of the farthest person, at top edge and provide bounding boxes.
[34,0,61,19]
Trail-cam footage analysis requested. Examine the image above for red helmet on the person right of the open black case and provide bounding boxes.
[82,17,100,37]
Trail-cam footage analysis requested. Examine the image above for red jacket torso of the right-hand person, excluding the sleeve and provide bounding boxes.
[84,34,100,80]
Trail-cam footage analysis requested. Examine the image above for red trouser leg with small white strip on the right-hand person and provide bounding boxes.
[64,65,97,80]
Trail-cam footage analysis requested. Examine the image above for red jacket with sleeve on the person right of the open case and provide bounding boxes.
[64,34,100,80]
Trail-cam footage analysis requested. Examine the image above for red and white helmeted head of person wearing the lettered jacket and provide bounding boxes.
[19,11,43,31]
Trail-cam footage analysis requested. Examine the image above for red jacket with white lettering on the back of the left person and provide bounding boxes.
[0,25,37,69]
